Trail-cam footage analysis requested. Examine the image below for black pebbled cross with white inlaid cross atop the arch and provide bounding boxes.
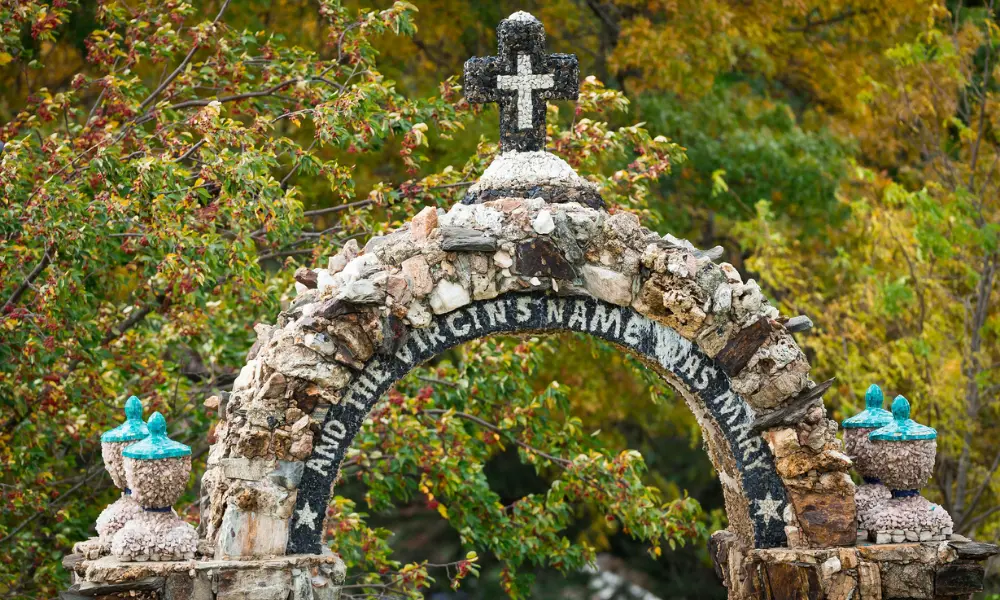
[463,11,580,152]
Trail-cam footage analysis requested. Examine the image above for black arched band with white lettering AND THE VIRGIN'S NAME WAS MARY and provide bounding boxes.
[288,293,786,554]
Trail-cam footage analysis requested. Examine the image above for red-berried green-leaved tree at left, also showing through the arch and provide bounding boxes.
[0,0,702,597]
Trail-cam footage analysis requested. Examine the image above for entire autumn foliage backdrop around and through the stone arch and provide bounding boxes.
[0,0,1000,598]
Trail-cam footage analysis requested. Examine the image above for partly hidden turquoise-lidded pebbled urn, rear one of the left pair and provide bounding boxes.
[80,396,149,558]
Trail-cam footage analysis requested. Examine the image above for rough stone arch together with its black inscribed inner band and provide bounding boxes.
[203,199,854,557]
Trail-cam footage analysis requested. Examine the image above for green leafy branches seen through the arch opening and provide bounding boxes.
[330,340,705,597]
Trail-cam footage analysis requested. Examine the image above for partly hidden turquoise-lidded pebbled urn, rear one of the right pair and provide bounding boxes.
[841,383,892,539]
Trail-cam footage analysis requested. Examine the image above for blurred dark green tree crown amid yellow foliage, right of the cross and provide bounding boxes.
[640,81,848,233]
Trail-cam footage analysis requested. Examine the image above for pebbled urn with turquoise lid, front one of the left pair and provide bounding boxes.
[111,412,198,561]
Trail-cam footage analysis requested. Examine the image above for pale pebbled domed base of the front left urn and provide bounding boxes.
[111,510,198,561]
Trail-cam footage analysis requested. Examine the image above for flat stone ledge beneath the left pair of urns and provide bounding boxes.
[60,551,346,600]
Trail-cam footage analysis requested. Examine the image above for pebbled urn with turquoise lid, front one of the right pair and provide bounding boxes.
[868,396,953,544]
